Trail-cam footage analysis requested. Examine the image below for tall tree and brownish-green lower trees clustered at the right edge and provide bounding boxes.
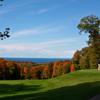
[73,15,100,69]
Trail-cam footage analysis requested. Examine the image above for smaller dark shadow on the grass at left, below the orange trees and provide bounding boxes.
[0,84,41,96]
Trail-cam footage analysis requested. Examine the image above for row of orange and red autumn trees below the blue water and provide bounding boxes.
[0,59,75,80]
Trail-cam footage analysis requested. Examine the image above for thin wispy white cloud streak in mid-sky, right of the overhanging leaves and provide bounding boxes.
[13,26,64,37]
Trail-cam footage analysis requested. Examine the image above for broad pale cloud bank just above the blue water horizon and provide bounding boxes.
[0,38,80,58]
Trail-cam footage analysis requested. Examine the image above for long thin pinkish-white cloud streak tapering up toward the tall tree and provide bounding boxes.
[0,38,77,51]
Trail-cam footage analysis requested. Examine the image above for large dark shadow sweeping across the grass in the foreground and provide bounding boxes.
[0,81,100,100]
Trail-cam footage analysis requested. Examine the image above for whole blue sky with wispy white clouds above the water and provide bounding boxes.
[0,0,100,58]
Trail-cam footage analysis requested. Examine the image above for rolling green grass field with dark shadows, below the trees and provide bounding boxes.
[0,70,100,100]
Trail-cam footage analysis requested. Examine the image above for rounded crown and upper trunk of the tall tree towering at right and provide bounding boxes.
[77,15,100,45]
